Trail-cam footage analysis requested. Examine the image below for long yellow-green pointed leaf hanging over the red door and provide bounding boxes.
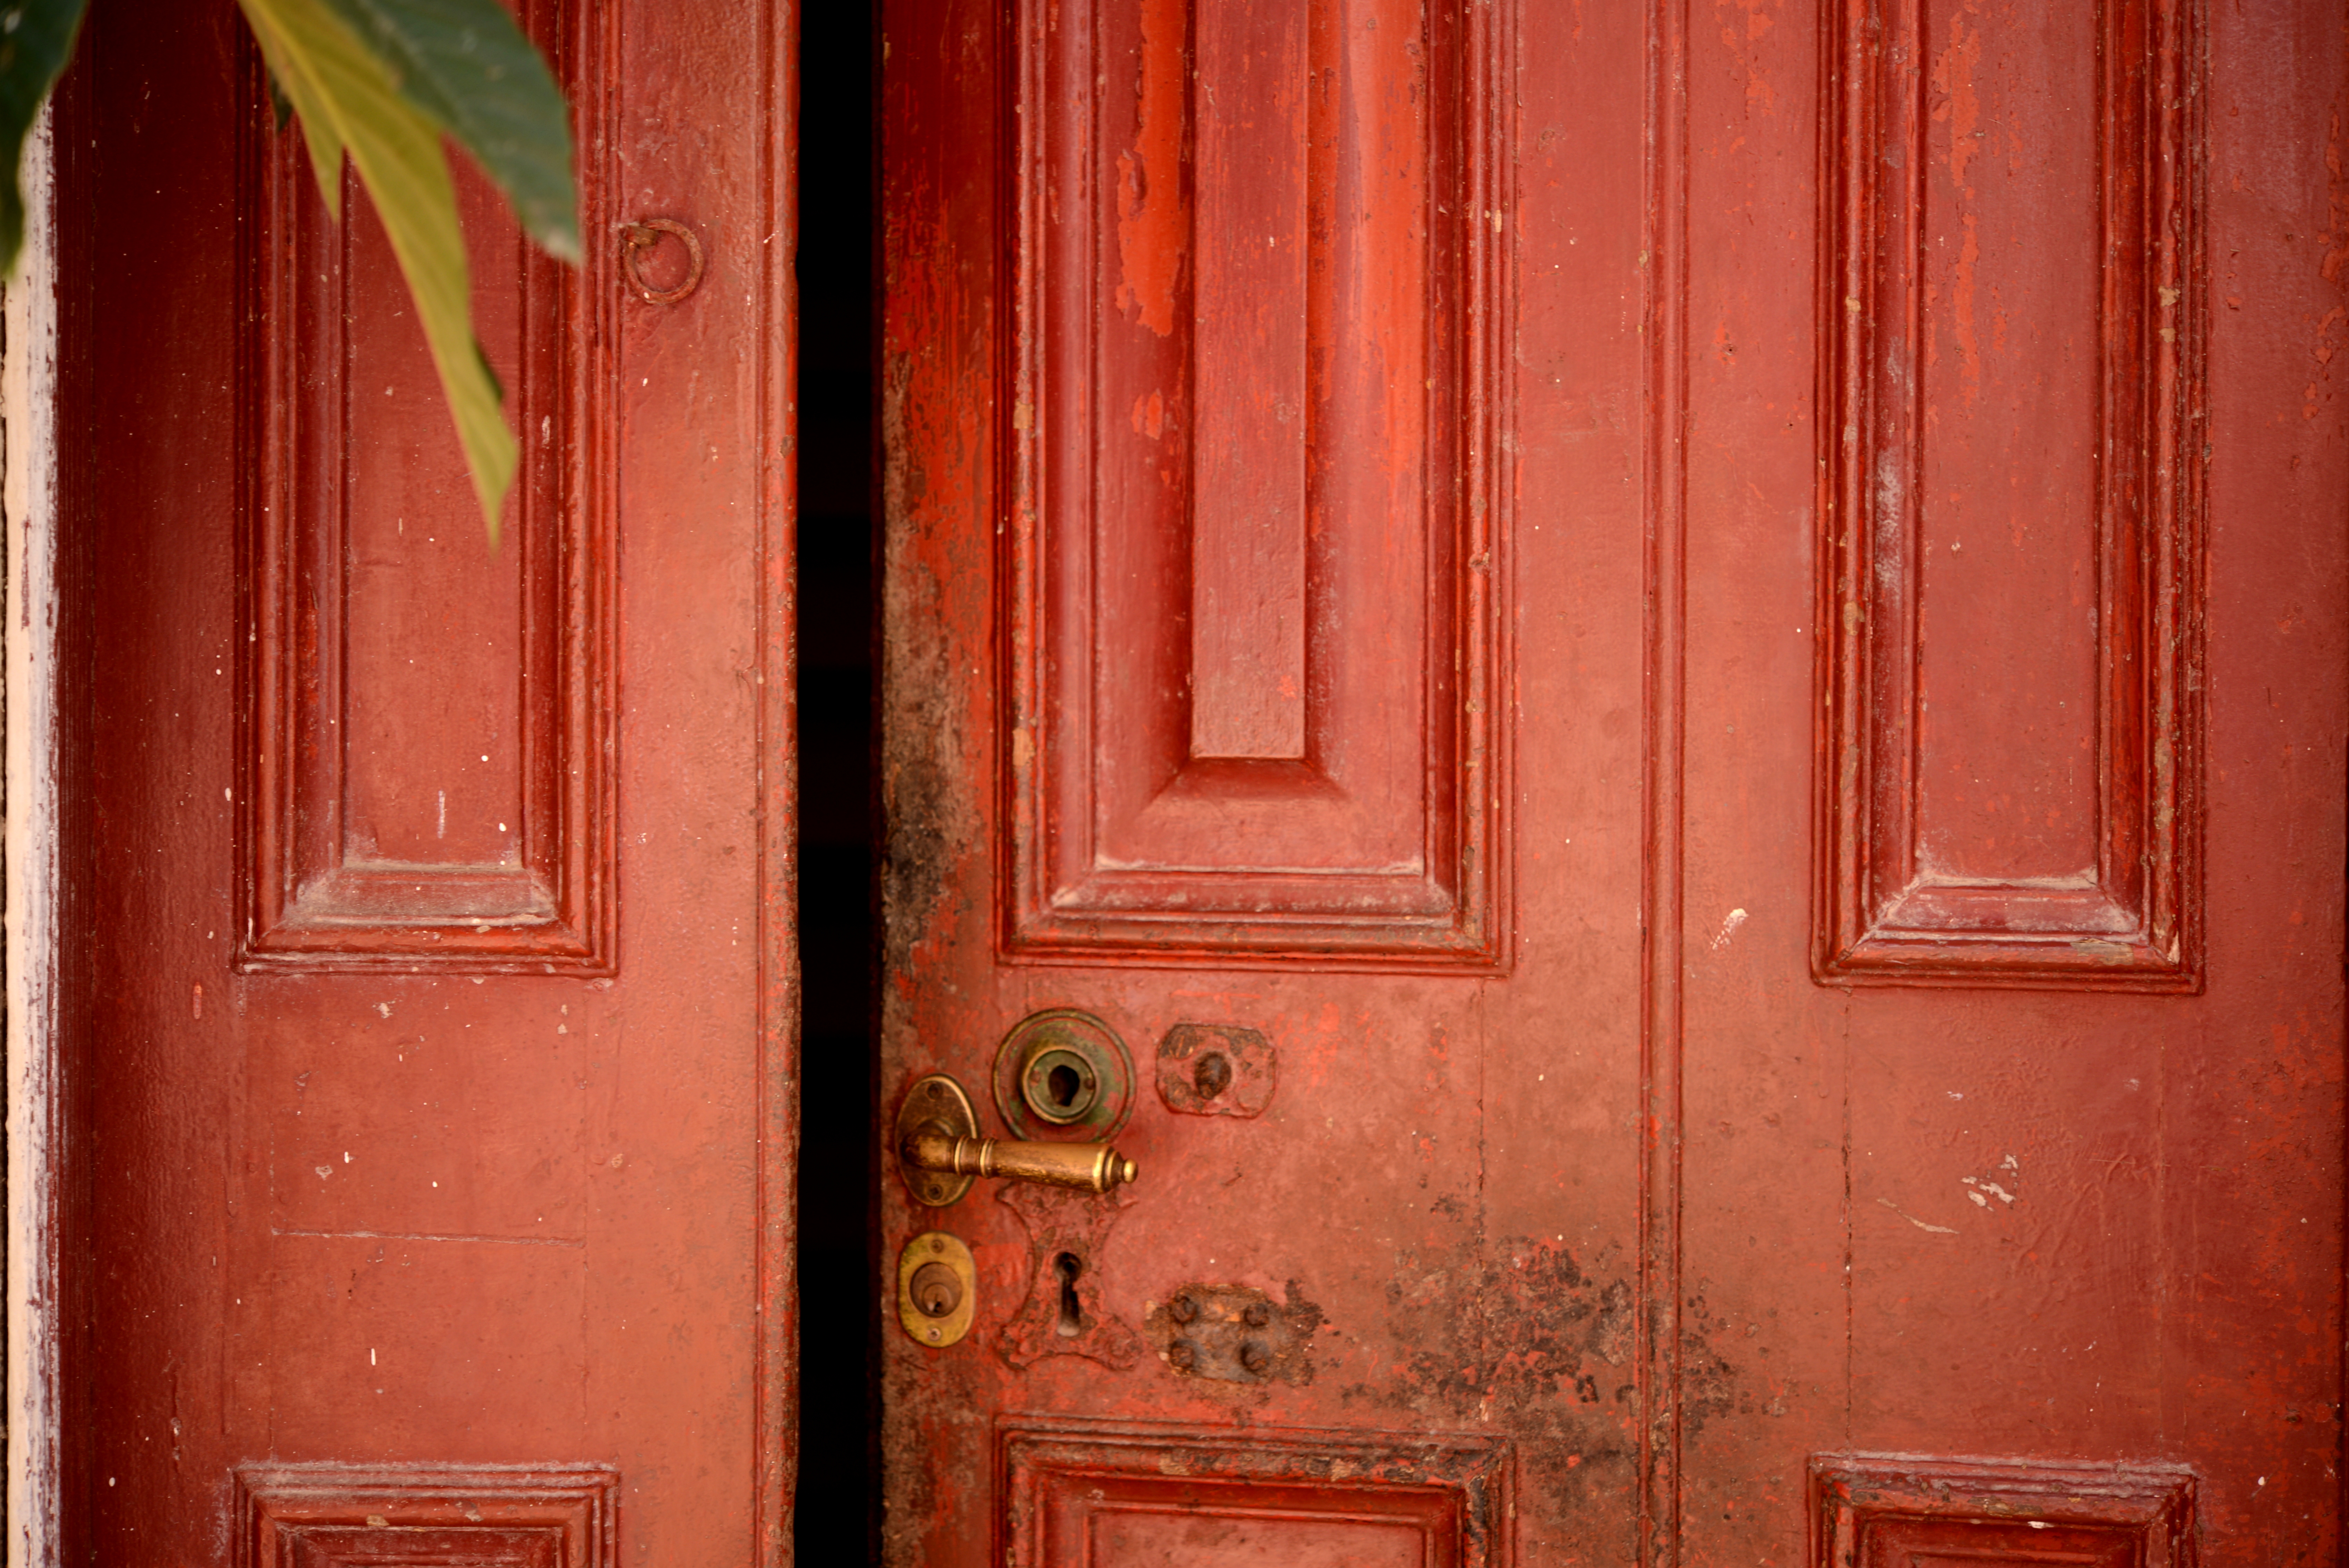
[237,0,519,545]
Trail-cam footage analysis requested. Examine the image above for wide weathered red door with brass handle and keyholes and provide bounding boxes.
[881,0,2349,1568]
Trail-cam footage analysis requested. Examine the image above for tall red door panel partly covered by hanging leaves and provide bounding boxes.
[235,0,618,974]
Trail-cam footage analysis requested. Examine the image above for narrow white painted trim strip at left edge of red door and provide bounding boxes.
[0,113,59,1568]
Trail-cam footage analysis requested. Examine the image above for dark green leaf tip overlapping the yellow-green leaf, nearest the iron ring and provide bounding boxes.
[326,0,580,260]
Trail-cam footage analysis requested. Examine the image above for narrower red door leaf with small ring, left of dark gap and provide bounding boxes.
[54,0,794,1568]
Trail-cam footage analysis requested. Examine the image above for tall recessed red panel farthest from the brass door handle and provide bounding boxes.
[1813,0,2208,991]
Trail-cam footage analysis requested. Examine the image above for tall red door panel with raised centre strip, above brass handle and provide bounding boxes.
[998,0,1508,965]
